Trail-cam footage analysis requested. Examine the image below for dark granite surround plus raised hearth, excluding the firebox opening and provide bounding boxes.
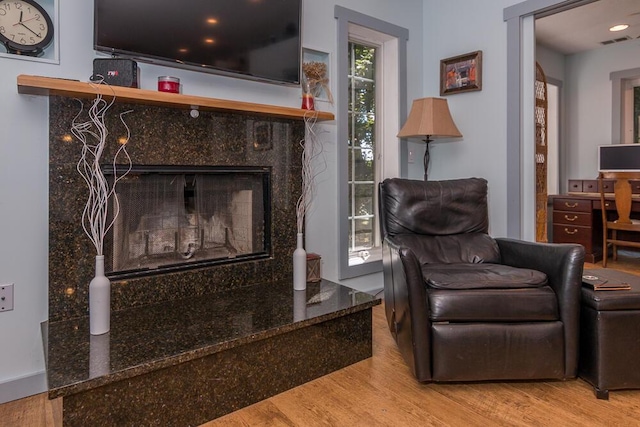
[43,91,380,427]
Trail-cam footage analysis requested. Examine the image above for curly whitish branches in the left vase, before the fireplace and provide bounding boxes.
[71,81,132,255]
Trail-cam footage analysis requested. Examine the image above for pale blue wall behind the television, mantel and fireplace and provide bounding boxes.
[0,0,424,402]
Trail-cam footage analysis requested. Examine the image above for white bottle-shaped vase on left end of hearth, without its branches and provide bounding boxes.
[89,255,111,335]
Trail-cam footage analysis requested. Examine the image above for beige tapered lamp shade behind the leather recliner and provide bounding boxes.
[398,98,462,139]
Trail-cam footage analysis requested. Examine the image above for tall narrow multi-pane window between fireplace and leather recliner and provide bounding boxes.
[335,6,409,279]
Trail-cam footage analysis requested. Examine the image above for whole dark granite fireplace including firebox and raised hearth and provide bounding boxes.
[30,77,380,426]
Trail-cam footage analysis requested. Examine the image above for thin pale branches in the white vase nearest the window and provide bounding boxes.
[296,111,326,233]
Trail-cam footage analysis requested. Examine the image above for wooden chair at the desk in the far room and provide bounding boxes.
[598,172,640,267]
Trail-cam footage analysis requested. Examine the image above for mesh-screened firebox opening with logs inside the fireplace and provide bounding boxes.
[106,167,270,277]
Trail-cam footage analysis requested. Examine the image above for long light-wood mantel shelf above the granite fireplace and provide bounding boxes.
[18,74,335,121]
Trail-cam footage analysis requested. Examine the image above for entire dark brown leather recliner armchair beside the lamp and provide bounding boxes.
[379,178,584,382]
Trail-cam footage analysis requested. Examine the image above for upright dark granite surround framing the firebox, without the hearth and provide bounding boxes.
[49,96,304,322]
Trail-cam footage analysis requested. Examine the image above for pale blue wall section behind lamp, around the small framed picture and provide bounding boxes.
[422,0,519,236]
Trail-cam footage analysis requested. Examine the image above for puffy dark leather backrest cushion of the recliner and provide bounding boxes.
[380,178,489,237]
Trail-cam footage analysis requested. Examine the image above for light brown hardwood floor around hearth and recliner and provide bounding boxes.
[5,257,640,427]
